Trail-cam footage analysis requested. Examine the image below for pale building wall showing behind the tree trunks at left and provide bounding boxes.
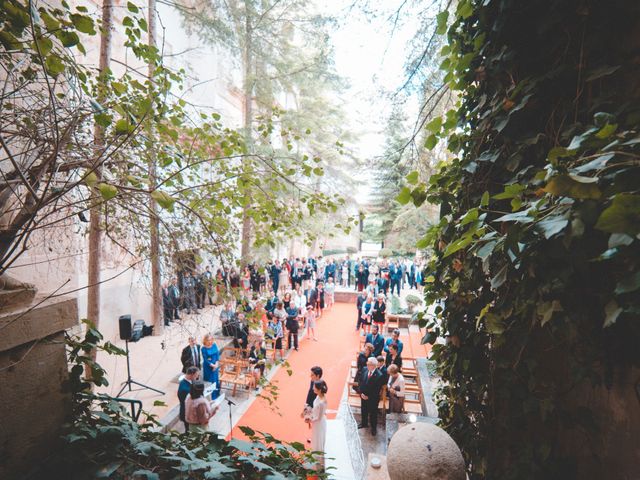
[8,0,242,340]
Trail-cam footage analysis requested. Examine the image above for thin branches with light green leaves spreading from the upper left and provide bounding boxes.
[0,0,349,273]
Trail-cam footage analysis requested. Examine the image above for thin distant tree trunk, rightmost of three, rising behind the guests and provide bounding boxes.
[240,14,253,265]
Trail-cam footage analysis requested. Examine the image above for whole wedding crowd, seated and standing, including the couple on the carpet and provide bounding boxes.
[171,251,423,462]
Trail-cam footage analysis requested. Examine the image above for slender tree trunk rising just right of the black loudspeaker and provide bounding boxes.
[148,0,164,335]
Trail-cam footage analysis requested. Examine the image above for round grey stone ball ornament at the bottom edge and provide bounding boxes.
[387,423,467,480]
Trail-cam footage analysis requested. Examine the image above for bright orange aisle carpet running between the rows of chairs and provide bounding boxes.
[233,303,360,443]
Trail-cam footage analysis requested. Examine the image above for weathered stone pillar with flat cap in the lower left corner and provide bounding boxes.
[0,298,78,480]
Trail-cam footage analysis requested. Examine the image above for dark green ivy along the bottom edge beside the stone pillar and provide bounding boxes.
[41,322,325,479]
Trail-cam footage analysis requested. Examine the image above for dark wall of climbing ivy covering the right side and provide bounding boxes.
[418,0,640,480]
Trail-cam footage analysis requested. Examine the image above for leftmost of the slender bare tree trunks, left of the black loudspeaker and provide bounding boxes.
[86,0,113,377]
